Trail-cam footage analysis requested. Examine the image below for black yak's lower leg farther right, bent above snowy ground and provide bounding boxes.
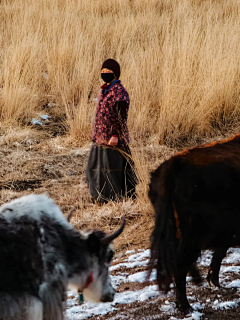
[207,247,228,287]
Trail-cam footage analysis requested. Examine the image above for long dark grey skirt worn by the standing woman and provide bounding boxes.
[86,145,137,202]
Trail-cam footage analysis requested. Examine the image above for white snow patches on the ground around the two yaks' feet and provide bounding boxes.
[66,248,240,320]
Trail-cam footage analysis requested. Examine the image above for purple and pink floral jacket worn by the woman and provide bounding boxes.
[92,80,130,149]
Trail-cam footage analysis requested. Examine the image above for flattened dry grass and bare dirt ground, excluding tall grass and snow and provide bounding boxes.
[0,119,240,320]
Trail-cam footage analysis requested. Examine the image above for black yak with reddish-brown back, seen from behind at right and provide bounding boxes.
[149,135,240,310]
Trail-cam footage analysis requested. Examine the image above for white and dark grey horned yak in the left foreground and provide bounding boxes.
[0,195,125,320]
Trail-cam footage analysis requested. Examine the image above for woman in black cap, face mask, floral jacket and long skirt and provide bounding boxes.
[86,59,137,202]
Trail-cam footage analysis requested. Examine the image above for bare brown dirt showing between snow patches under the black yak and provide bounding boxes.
[101,273,240,320]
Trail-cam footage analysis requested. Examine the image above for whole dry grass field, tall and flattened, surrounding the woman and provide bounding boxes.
[0,0,240,264]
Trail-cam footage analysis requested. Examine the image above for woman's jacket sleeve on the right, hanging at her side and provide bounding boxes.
[112,101,128,138]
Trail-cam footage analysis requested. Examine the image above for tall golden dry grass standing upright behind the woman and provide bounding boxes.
[0,0,240,142]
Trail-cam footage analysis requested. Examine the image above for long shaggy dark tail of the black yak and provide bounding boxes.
[149,161,177,293]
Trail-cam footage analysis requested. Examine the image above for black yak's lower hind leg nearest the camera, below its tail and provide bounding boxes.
[175,268,191,311]
